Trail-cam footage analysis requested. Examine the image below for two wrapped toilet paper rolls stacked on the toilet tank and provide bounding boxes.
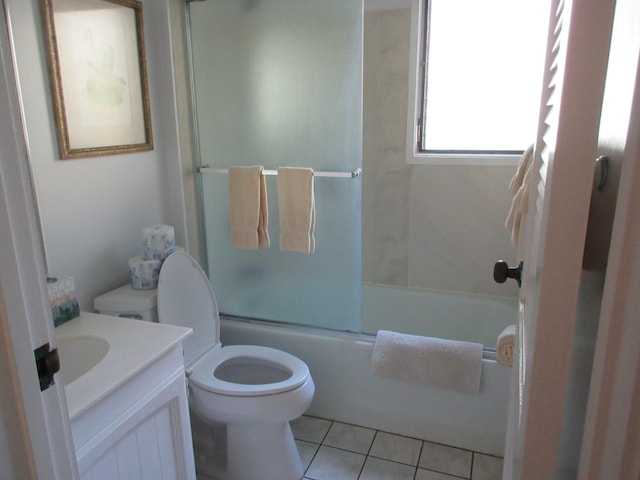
[129,225,176,290]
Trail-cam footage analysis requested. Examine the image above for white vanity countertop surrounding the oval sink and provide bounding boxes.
[55,312,192,421]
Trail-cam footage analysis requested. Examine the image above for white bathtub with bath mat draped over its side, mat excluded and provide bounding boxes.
[220,287,517,456]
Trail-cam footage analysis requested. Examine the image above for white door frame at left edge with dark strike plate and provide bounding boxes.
[0,2,78,480]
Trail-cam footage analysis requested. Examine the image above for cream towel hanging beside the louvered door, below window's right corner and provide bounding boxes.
[505,145,533,258]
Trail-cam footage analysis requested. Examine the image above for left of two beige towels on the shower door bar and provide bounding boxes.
[229,165,270,250]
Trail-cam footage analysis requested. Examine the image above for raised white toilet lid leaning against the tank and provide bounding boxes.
[158,252,220,366]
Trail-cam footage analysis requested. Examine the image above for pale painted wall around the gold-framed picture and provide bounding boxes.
[5,0,188,310]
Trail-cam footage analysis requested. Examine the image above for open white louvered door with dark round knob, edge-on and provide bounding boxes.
[504,0,615,480]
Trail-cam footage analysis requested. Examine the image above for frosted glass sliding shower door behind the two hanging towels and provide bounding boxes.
[188,0,362,331]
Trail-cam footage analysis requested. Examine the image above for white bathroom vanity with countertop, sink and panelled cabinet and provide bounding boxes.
[56,312,195,480]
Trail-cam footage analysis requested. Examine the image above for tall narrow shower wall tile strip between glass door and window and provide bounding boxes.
[362,9,411,286]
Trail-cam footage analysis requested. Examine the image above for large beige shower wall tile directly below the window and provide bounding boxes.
[409,166,517,296]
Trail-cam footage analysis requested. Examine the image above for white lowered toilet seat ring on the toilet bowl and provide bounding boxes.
[189,345,309,396]
